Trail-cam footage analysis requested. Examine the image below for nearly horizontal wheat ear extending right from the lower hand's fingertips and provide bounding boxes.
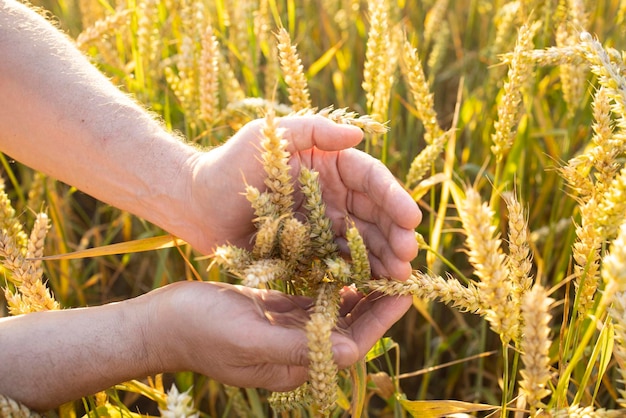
[367,271,485,314]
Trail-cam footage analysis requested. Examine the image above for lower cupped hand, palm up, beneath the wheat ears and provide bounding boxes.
[146,282,411,391]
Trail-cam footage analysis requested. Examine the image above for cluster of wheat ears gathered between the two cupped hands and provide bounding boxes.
[215,105,380,412]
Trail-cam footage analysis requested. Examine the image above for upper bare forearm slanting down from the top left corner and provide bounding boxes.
[0,0,196,237]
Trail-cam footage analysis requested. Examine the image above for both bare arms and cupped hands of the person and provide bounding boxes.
[0,0,421,409]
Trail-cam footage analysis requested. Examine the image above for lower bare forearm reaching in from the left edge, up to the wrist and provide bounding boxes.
[0,301,155,410]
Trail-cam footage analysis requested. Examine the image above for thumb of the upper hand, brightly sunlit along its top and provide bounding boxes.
[279,115,363,153]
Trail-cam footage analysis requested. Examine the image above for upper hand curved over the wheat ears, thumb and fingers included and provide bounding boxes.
[183,116,421,279]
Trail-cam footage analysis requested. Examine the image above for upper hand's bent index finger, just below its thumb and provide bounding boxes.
[337,149,422,229]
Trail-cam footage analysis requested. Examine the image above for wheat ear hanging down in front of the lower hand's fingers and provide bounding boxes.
[305,283,339,415]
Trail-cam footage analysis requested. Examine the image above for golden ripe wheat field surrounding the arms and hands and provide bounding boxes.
[0,0,626,417]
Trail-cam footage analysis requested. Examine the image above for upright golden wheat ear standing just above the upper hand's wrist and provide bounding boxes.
[200,25,220,126]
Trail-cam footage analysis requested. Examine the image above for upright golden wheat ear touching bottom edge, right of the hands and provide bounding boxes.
[520,284,553,415]
